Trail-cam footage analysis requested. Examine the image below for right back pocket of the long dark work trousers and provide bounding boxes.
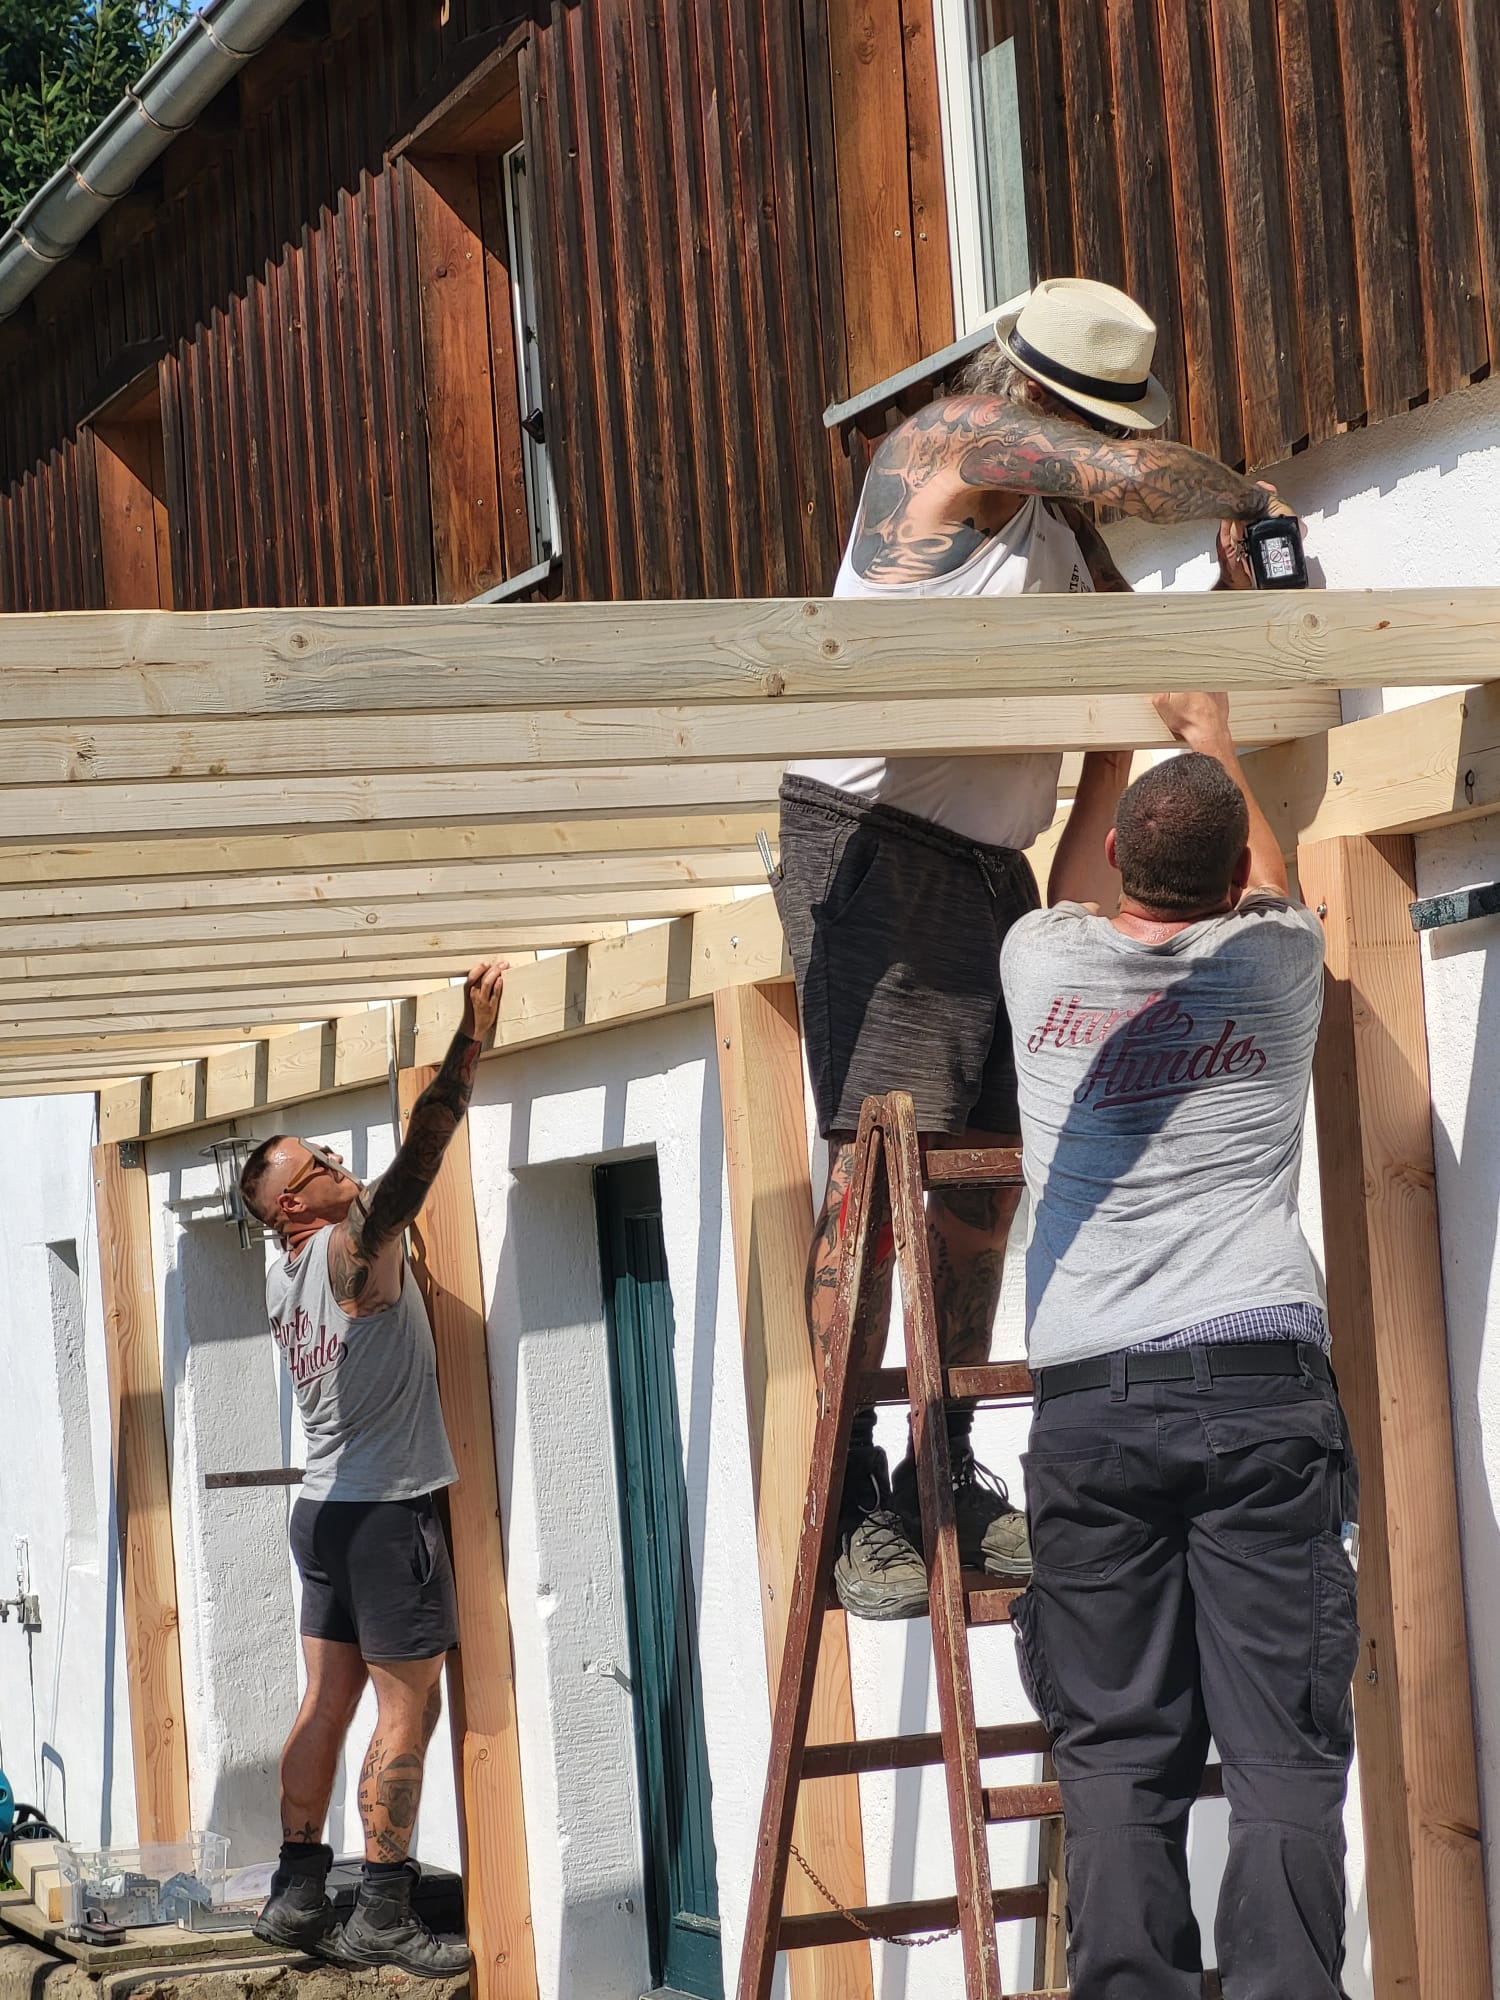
[1200,1402,1344,1556]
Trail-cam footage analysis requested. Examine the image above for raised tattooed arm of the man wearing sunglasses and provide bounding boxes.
[328,962,506,1318]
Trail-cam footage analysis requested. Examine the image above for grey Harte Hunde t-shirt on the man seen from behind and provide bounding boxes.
[1000,894,1322,1368]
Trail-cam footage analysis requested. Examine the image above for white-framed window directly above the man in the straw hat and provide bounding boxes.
[932,0,1032,334]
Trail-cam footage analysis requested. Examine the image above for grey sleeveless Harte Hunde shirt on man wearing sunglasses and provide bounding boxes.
[266,1230,458,1500]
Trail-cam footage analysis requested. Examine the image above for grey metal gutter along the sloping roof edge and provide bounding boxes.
[0,0,302,320]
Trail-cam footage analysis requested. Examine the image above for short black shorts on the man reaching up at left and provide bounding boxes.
[292,1494,458,1662]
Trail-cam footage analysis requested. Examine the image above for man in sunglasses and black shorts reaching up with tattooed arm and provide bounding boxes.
[240,962,506,1978]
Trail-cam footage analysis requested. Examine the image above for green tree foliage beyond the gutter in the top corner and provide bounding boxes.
[0,0,192,224]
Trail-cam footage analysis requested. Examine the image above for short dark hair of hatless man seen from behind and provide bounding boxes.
[1114,750,1250,916]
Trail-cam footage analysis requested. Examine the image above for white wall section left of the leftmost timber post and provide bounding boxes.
[0,1098,136,1846]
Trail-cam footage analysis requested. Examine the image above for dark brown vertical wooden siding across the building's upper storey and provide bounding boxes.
[0,0,1500,610]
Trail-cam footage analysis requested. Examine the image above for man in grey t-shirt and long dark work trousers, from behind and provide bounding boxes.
[1000,696,1358,2000]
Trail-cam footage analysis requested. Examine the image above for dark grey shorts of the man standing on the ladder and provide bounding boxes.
[776,776,1040,1134]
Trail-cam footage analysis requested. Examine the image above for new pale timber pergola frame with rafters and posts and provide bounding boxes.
[20,590,1500,2000]
